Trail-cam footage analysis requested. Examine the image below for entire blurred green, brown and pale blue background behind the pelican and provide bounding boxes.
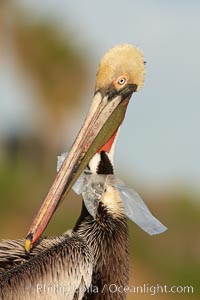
[0,0,200,299]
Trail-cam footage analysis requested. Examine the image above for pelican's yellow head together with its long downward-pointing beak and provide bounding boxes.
[25,44,145,252]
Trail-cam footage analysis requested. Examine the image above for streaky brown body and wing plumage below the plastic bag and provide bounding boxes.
[0,190,129,300]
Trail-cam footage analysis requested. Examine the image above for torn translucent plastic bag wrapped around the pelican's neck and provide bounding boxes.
[57,153,167,235]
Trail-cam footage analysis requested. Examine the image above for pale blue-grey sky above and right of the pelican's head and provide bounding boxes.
[0,0,200,185]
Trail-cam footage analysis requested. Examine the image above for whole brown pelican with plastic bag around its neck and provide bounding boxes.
[0,45,166,300]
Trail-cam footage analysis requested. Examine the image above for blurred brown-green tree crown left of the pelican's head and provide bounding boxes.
[14,19,87,125]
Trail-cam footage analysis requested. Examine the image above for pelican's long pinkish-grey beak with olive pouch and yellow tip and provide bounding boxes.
[25,87,135,252]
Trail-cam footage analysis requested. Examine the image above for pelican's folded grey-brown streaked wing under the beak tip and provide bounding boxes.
[0,233,93,300]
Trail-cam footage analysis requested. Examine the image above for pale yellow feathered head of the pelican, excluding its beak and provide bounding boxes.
[95,44,145,93]
